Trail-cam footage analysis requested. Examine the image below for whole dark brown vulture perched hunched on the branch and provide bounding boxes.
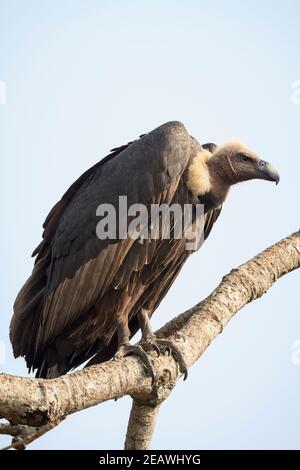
[10,121,279,378]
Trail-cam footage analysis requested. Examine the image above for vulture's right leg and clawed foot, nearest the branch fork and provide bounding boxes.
[138,308,188,380]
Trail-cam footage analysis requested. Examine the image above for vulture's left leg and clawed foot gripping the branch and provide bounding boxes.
[114,304,155,382]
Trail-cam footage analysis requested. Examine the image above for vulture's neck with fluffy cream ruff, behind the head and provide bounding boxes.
[187,150,232,212]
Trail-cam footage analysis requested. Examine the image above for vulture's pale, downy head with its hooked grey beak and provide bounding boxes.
[208,141,279,185]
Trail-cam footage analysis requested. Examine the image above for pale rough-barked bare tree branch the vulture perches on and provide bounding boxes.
[0,231,300,448]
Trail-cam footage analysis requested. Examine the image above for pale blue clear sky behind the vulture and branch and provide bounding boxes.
[0,0,300,449]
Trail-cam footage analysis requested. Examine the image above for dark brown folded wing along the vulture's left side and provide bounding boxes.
[10,122,190,369]
